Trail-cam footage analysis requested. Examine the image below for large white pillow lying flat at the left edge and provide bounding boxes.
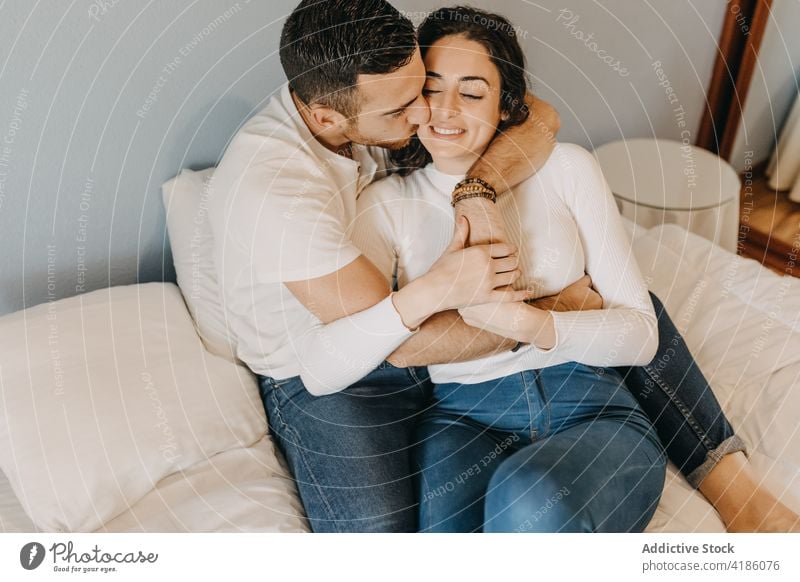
[0,283,267,531]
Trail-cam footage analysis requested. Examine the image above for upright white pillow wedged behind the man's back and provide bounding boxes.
[161,168,237,361]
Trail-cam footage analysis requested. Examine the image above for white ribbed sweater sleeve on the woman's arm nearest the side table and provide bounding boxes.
[534,144,658,367]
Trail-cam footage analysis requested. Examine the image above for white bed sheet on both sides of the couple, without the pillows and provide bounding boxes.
[0,223,800,532]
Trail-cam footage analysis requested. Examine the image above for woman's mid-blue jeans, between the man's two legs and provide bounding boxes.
[416,363,666,532]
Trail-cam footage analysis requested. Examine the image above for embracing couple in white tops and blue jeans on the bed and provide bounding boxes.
[209,0,796,532]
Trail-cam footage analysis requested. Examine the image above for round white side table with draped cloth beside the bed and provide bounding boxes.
[594,139,741,253]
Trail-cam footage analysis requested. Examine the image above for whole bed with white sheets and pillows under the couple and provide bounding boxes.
[0,170,800,532]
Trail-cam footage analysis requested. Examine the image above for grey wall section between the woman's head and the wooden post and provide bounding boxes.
[395,0,727,148]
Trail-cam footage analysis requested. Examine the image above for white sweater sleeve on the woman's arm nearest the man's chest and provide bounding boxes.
[300,178,414,396]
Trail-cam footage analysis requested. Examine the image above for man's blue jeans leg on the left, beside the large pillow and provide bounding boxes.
[259,363,432,532]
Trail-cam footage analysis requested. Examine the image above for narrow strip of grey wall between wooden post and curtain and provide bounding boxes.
[731,0,800,171]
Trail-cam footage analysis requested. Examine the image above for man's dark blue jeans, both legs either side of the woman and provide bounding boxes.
[259,294,744,531]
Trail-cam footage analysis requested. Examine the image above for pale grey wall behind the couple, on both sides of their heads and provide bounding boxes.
[0,0,726,314]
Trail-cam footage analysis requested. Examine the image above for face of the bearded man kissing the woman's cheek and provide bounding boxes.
[345,48,430,149]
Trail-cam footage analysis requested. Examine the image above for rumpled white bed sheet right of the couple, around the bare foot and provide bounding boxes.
[633,225,800,532]
